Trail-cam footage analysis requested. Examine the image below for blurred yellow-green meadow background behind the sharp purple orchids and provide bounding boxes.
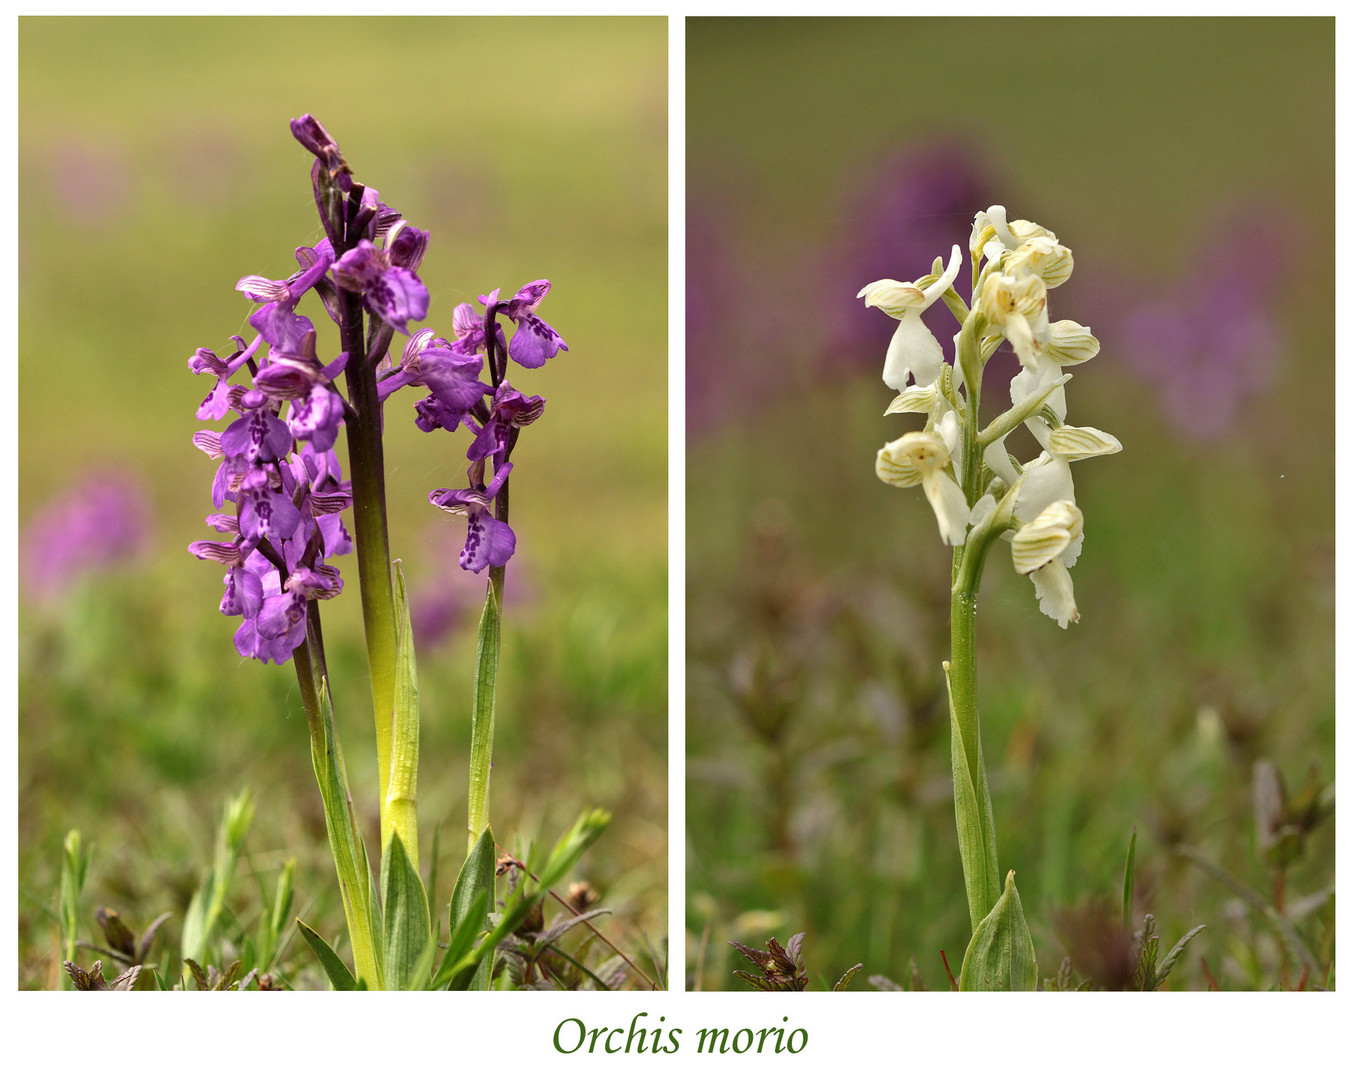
[19,19,667,987]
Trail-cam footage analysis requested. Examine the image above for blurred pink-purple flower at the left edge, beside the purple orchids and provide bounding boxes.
[19,470,150,602]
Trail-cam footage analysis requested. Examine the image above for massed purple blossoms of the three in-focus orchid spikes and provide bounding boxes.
[188,115,568,663]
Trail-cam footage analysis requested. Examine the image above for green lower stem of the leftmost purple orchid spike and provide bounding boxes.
[291,630,383,989]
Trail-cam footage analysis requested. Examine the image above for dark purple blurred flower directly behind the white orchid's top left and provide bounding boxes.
[820,142,996,369]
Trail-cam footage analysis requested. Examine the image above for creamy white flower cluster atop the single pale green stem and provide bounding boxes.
[859,206,1122,629]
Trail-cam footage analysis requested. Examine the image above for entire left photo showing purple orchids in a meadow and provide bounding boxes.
[18,18,671,991]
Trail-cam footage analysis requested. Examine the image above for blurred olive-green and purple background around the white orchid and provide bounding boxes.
[686,19,1334,989]
